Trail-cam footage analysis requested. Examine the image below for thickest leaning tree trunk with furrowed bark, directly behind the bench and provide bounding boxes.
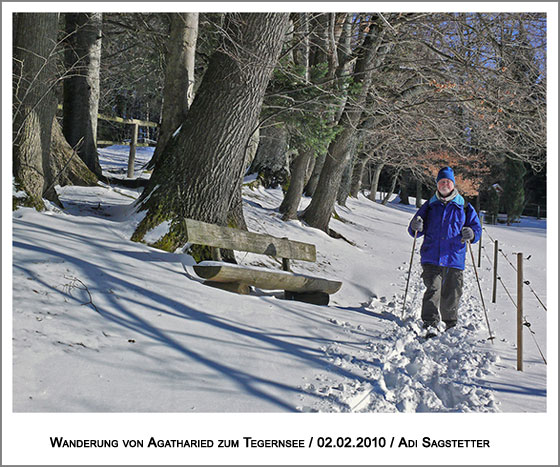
[132,13,289,250]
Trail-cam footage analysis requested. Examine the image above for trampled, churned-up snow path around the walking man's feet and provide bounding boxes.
[300,264,500,412]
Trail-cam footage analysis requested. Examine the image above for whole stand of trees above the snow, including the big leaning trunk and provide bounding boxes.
[13,12,547,243]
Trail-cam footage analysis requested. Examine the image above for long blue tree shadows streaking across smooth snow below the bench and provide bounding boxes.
[13,236,370,412]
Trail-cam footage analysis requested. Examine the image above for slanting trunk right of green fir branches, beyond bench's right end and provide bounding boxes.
[302,25,382,232]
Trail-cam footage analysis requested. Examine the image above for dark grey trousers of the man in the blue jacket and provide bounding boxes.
[422,264,463,326]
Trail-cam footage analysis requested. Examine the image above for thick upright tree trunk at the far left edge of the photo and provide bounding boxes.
[12,13,58,209]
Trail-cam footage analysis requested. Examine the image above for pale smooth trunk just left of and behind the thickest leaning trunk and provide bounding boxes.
[148,13,198,168]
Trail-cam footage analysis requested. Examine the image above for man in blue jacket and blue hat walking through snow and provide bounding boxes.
[408,167,482,337]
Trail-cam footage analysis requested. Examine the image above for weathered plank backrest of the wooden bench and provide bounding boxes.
[185,219,317,262]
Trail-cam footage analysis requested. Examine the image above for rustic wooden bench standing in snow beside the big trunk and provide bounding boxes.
[185,219,342,305]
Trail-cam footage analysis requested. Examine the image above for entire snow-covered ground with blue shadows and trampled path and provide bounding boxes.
[4,148,557,464]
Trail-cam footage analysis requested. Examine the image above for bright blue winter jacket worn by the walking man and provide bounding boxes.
[408,194,482,269]
